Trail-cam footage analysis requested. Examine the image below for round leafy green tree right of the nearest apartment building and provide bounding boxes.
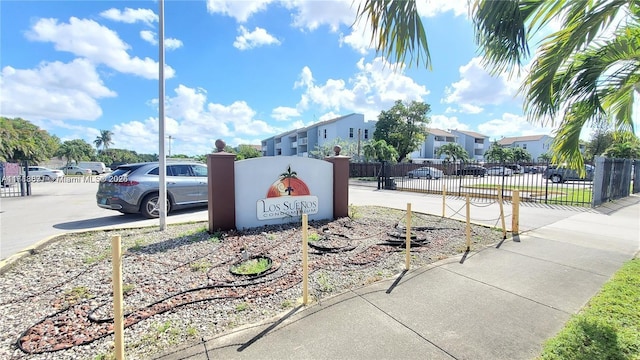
[373,100,431,162]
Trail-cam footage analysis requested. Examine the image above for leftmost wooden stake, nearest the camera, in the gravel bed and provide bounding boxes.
[111,235,124,359]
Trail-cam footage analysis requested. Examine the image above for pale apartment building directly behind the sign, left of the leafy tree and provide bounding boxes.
[262,113,376,157]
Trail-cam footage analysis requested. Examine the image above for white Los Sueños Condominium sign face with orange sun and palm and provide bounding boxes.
[236,156,333,229]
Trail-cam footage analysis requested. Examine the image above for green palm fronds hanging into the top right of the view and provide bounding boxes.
[357,0,640,171]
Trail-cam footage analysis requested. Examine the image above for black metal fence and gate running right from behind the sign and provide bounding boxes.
[351,162,595,206]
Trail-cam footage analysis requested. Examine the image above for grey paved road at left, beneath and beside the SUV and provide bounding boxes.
[0,177,207,260]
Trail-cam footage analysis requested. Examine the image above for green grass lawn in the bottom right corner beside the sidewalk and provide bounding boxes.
[540,259,640,360]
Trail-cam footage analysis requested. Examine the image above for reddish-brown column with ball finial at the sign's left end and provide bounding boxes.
[207,140,236,234]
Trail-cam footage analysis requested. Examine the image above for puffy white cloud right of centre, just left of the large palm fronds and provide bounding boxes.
[443,57,520,113]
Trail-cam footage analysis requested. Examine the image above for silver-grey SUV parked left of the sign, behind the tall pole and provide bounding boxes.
[96,162,208,218]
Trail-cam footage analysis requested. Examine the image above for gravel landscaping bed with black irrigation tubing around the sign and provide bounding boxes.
[0,207,510,359]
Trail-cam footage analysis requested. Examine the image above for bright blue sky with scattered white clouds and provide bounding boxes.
[0,0,604,155]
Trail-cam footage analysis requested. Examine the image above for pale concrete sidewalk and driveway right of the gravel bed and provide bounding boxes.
[156,187,640,359]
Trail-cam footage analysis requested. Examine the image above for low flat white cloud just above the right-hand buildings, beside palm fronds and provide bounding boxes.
[478,113,553,140]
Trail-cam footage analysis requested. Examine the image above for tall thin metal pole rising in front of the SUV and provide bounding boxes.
[158,0,167,231]
